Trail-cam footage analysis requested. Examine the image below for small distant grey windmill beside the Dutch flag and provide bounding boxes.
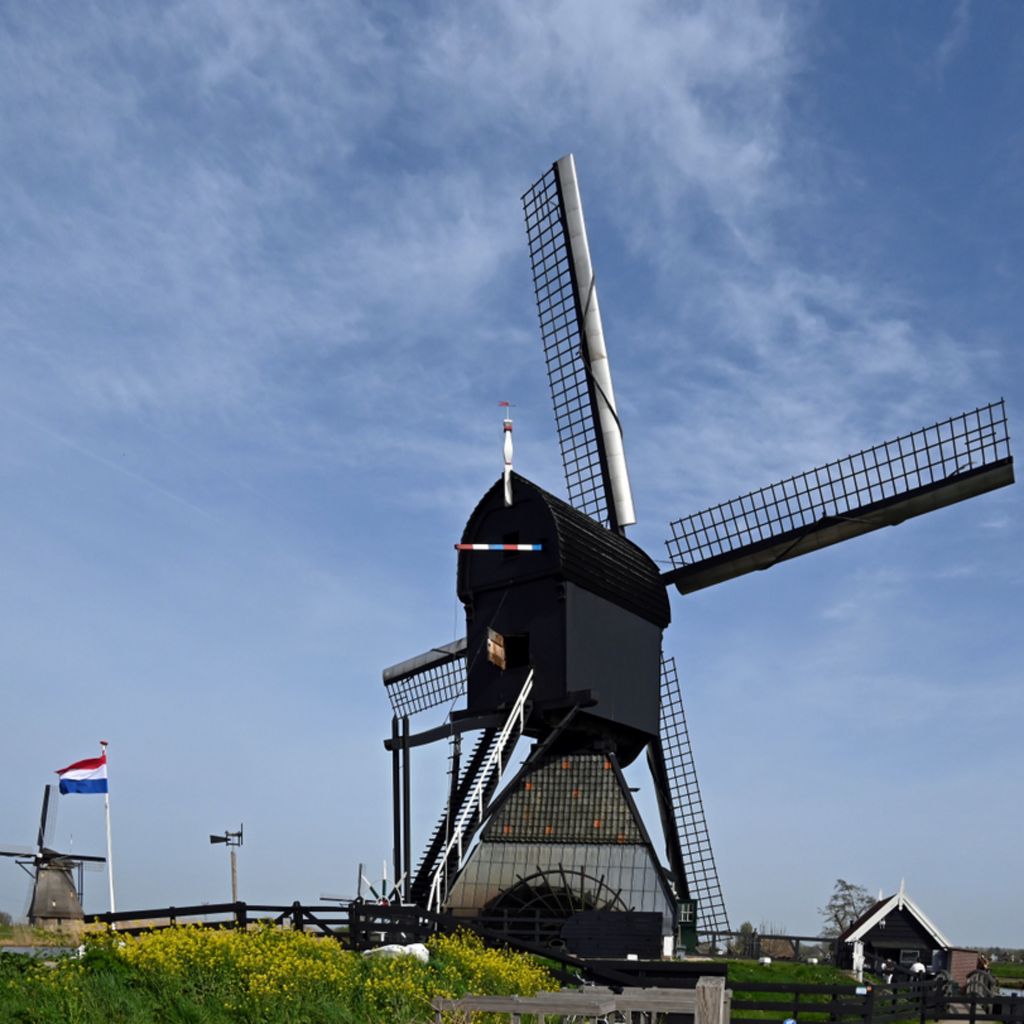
[0,785,106,926]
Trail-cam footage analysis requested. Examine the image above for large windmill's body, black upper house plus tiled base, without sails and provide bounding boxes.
[445,474,677,955]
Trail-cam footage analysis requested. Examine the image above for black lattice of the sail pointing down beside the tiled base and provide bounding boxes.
[659,654,729,934]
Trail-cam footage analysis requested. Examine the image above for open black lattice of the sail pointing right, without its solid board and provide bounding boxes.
[666,399,1010,568]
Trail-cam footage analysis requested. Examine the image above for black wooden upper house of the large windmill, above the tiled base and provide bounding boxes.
[458,474,671,764]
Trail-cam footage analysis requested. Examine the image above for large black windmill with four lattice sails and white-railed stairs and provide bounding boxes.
[383,156,1014,955]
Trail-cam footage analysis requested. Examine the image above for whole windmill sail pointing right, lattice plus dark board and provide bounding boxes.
[663,399,1014,594]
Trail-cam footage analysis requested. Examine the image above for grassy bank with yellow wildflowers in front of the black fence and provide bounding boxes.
[0,928,557,1024]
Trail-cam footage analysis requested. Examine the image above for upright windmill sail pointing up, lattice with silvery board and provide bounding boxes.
[522,154,636,530]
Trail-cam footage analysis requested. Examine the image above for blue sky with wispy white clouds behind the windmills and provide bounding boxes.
[0,0,1024,945]
